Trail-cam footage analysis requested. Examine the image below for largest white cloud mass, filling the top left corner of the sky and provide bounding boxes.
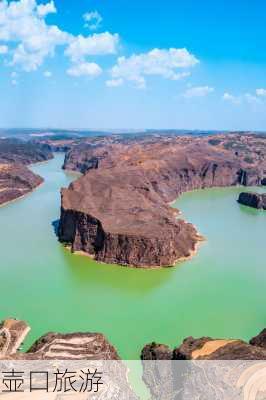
[0,0,71,71]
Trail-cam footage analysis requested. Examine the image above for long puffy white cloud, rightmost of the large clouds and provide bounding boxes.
[111,48,199,88]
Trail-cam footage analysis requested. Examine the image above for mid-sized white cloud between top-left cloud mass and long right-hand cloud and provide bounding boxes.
[65,32,119,62]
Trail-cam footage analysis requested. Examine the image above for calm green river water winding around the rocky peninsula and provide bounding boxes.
[0,154,266,359]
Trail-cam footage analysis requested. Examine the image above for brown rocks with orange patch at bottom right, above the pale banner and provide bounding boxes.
[141,330,266,360]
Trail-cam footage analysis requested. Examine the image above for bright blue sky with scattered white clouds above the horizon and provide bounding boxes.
[0,0,266,130]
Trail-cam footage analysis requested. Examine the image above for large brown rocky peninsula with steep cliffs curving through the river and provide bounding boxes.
[59,135,266,267]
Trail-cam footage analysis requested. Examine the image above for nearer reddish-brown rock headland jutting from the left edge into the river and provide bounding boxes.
[0,164,43,205]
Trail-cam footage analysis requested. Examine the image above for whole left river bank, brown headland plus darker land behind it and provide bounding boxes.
[0,139,52,205]
